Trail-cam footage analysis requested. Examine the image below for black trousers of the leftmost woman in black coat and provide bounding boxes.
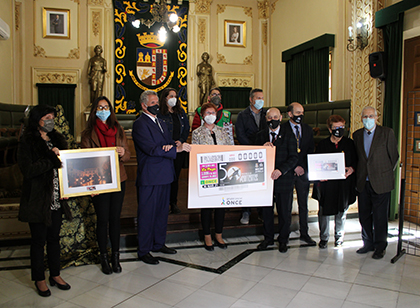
[29,209,62,281]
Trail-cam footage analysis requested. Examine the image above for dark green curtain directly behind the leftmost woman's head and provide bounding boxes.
[36,83,76,135]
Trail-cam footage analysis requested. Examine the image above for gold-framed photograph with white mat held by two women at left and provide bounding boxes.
[58,147,121,198]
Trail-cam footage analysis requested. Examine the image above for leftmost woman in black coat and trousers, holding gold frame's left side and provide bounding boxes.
[18,105,71,297]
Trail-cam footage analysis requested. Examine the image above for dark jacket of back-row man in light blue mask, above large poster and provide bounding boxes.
[235,106,267,145]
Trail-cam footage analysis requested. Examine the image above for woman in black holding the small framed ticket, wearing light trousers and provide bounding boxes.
[312,115,357,249]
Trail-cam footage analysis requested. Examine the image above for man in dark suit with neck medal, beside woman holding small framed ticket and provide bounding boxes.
[281,102,316,246]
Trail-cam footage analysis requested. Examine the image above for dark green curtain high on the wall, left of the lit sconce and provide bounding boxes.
[286,47,329,105]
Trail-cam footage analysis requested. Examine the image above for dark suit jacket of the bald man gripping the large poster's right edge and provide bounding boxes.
[255,126,299,193]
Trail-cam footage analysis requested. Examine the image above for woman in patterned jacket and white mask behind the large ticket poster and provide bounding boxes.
[192,103,233,251]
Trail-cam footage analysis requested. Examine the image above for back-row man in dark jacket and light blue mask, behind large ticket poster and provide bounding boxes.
[235,88,267,225]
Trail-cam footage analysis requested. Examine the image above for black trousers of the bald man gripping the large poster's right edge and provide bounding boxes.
[262,189,293,244]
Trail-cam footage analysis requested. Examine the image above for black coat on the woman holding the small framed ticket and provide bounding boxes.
[312,137,357,215]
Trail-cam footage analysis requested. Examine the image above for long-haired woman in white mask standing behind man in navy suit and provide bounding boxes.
[157,88,190,214]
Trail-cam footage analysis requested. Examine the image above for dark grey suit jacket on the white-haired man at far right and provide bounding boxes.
[353,125,399,194]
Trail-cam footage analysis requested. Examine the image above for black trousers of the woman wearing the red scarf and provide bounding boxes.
[92,181,125,253]
